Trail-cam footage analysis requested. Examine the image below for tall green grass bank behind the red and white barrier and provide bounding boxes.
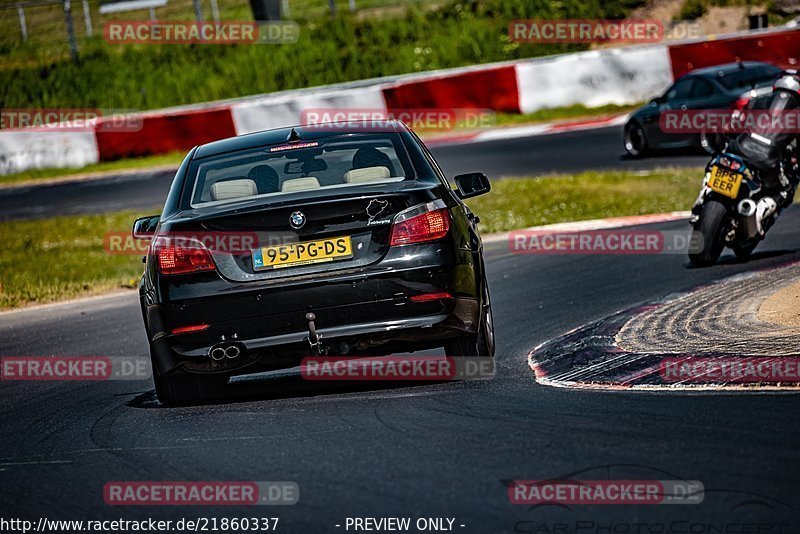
[0,0,643,110]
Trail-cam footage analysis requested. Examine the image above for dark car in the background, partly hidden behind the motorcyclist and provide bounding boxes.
[624,61,781,157]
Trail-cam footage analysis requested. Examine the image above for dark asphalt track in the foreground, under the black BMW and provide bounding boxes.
[0,125,800,534]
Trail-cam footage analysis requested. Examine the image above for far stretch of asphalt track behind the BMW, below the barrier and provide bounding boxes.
[0,126,708,221]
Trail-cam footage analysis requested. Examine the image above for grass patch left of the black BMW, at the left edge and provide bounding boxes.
[0,208,159,309]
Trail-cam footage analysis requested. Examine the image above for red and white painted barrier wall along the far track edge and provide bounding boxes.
[0,26,800,174]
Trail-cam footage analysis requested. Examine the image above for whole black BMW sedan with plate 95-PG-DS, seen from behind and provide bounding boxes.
[134,121,494,404]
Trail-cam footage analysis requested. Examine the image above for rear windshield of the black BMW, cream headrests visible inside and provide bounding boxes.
[189,133,413,207]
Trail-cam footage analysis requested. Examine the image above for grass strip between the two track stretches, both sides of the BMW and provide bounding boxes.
[0,169,702,309]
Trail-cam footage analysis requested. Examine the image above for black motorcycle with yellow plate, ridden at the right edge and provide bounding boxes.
[689,143,797,267]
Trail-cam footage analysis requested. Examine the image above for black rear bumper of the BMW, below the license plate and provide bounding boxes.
[143,246,480,374]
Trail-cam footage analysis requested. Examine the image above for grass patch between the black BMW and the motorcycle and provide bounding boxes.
[467,169,703,233]
